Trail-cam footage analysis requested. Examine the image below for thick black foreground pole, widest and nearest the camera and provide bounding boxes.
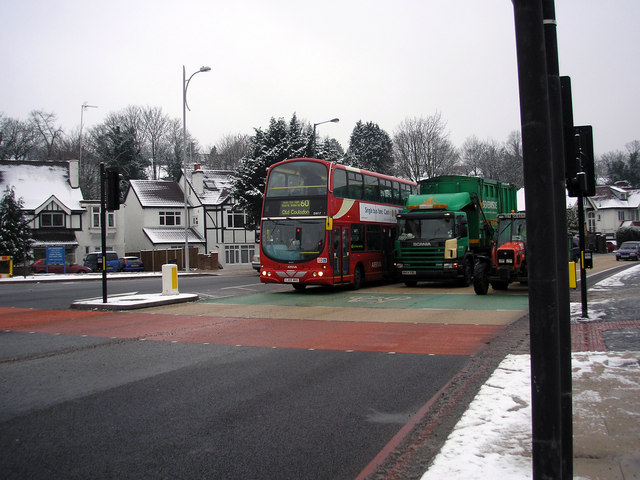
[513,0,566,480]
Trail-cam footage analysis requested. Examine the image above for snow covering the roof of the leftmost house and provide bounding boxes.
[0,161,82,210]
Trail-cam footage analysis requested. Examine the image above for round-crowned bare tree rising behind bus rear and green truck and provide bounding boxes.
[393,112,458,181]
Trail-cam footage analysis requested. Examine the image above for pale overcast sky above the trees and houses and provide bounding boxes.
[0,0,640,154]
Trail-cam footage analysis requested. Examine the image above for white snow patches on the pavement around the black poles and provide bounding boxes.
[422,265,640,480]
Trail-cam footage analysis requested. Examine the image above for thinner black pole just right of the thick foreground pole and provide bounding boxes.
[542,0,573,479]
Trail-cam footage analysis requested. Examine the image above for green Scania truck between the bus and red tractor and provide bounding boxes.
[395,175,517,286]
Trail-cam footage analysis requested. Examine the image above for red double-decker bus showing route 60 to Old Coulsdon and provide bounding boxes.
[260,158,417,290]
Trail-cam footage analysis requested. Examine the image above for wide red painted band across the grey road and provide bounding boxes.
[0,307,504,355]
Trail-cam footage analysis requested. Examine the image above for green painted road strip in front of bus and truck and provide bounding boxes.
[204,291,529,311]
